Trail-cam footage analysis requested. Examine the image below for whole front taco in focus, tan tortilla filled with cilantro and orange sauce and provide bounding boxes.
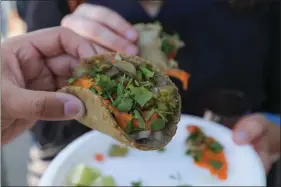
[60,53,181,150]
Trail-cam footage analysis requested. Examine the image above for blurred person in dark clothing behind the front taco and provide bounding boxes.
[17,0,280,185]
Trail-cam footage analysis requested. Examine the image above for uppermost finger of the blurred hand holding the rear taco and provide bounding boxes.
[75,4,138,42]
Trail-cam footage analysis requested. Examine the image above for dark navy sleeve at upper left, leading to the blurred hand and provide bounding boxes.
[17,1,70,32]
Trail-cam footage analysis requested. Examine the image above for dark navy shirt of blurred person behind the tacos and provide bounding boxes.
[18,0,280,148]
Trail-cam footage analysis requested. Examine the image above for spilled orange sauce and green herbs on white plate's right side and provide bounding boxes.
[186,125,228,180]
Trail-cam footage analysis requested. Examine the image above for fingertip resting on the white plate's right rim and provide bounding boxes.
[233,114,267,144]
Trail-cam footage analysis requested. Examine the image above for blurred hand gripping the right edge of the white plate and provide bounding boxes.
[233,114,280,173]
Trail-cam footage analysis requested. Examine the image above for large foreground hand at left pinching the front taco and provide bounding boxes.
[1,28,95,144]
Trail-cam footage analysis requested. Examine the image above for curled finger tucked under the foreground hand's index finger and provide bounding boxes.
[45,54,80,77]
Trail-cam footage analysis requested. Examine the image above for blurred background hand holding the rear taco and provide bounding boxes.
[61,3,138,55]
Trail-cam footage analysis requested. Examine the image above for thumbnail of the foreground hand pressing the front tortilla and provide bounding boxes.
[57,93,84,119]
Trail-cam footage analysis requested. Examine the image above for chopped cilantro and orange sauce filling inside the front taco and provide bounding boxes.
[69,54,179,143]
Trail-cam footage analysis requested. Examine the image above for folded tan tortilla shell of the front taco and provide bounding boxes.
[60,53,181,150]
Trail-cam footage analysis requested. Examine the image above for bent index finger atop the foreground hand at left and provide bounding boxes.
[5,27,95,61]
